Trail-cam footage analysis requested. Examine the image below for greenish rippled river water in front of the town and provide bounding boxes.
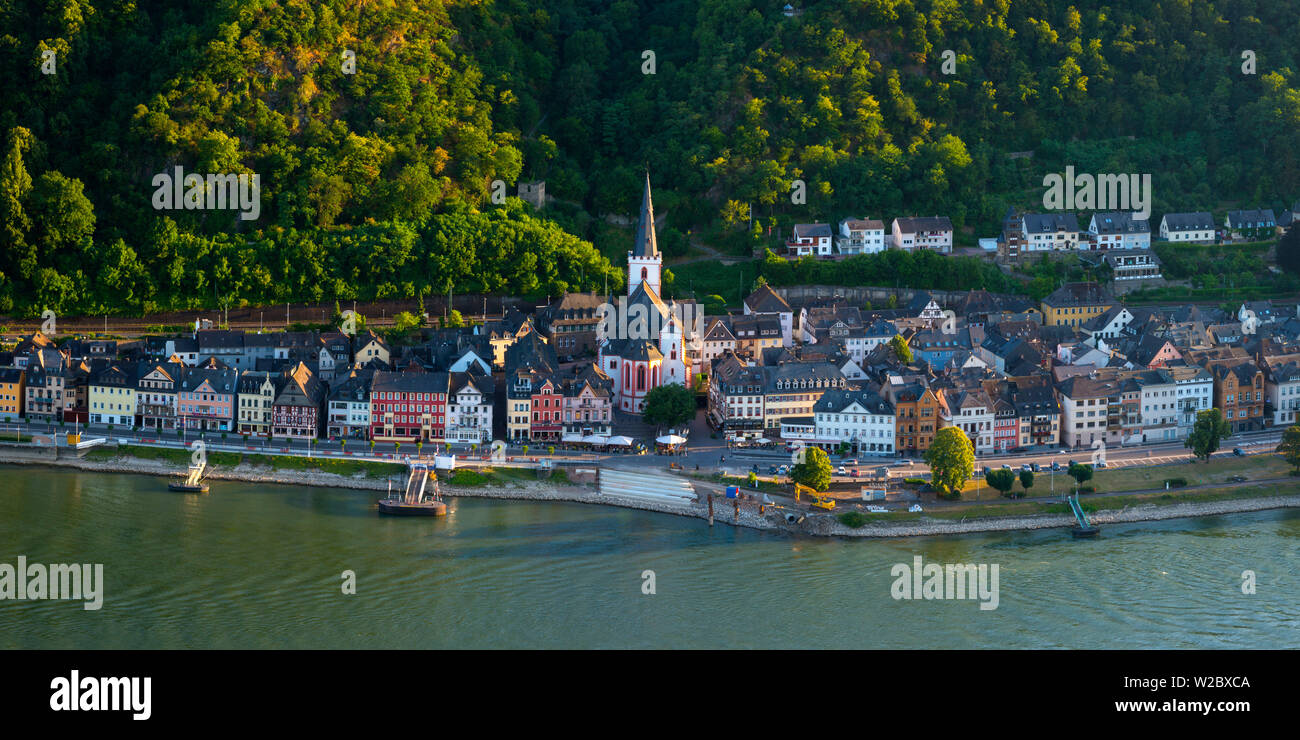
[0,466,1300,649]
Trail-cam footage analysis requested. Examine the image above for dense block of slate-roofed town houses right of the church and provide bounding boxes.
[705,284,1300,455]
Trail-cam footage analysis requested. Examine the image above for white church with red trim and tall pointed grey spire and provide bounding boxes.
[597,173,702,414]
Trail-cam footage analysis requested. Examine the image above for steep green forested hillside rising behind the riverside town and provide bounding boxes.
[0,0,1300,315]
